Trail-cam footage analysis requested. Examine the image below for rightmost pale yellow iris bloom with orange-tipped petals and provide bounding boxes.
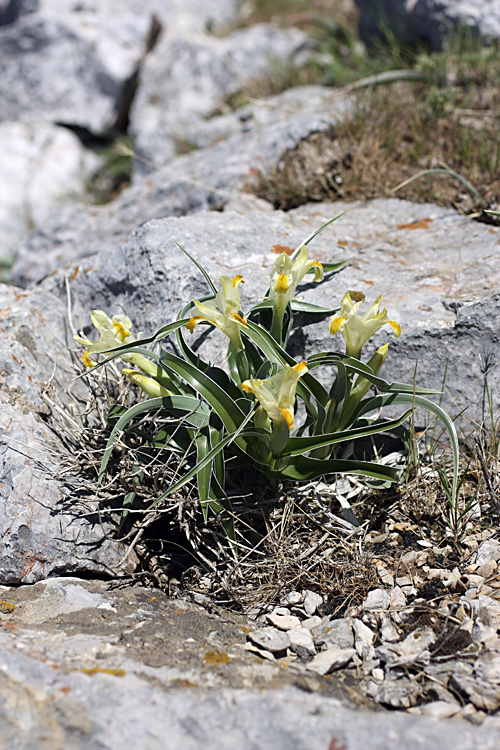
[330,292,401,358]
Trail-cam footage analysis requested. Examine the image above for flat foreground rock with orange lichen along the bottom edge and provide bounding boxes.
[0,578,500,750]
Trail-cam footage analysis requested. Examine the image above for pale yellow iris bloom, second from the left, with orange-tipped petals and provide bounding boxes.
[186,275,247,349]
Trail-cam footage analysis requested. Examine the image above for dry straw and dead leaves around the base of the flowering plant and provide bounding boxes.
[45,366,500,617]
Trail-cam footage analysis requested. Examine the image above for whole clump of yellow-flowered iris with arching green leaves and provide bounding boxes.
[68,217,458,608]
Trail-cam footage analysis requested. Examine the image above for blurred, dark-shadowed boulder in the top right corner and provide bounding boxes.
[356,0,500,50]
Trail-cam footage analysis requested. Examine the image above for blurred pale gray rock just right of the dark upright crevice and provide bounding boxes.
[131,24,307,174]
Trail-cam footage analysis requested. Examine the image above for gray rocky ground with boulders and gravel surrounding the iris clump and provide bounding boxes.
[0,0,500,750]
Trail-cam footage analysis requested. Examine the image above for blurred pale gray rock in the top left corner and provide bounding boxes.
[0,0,158,132]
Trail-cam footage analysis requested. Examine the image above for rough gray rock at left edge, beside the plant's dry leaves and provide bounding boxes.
[0,286,136,584]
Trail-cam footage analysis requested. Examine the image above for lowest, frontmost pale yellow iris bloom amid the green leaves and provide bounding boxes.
[241,362,308,430]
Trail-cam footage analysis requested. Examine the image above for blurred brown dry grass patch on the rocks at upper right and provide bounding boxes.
[249,82,500,221]
